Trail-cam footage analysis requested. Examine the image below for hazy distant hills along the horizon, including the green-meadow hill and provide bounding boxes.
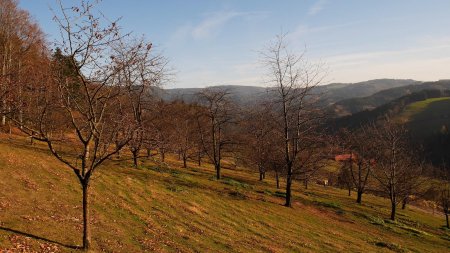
[154,79,450,165]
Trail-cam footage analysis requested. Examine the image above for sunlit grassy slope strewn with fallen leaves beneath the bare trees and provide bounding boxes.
[0,136,450,252]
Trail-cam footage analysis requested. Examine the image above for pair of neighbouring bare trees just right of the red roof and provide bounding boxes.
[336,119,424,220]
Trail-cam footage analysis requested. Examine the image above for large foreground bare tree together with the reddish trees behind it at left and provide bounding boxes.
[0,0,167,250]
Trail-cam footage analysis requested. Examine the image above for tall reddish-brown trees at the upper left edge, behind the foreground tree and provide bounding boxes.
[0,0,48,128]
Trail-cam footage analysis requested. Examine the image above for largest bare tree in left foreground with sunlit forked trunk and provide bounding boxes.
[13,2,164,250]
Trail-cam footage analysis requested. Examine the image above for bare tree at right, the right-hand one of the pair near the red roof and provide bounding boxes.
[372,119,422,220]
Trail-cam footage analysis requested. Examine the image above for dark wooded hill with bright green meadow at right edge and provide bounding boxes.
[330,90,450,165]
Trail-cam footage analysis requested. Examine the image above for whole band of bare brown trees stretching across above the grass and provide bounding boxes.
[0,0,450,252]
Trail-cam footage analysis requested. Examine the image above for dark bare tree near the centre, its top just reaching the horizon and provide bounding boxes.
[197,88,233,179]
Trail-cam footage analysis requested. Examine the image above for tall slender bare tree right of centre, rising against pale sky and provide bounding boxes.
[262,34,324,206]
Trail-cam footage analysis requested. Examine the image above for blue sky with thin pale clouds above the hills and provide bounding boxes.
[19,0,450,88]
